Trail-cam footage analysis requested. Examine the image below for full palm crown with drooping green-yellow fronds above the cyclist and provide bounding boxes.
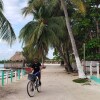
[19,3,64,61]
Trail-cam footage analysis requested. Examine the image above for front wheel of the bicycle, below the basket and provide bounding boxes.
[27,81,35,97]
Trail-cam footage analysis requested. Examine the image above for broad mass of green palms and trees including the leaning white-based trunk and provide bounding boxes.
[19,0,100,78]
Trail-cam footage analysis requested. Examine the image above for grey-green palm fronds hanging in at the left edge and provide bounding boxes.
[0,0,16,45]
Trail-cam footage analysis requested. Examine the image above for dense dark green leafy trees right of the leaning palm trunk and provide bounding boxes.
[72,0,100,60]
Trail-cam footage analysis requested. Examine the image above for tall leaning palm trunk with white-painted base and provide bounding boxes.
[60,0,86,78]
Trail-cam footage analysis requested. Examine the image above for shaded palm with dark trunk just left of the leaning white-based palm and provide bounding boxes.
[52,30,73,72]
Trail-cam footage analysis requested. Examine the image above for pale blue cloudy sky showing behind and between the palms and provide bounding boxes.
[0,0,53,60]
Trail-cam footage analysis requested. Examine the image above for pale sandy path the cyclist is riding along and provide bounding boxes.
[0,65,100,100]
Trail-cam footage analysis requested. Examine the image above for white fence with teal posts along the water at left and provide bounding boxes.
[0,69,26,86]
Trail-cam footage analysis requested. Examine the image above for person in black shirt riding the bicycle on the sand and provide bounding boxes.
[31,58,42,85]
